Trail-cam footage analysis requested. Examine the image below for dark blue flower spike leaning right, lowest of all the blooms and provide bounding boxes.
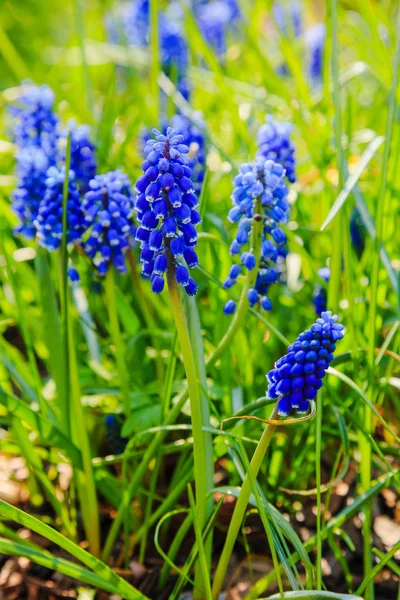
[267,311,344,416]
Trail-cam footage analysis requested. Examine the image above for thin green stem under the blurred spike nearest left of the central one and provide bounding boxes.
[106,266,130,416]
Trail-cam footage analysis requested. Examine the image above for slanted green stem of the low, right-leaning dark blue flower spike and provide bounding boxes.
[212,404,278,600]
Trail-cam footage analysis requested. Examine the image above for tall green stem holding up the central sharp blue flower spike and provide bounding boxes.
[167,261,208,600]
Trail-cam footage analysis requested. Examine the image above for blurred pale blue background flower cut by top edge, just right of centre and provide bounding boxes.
[194,0,240,55]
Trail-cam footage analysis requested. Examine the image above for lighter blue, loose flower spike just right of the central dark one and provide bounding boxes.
[224,156,289,315]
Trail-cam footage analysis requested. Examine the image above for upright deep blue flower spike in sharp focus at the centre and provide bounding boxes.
[135,127,201,296]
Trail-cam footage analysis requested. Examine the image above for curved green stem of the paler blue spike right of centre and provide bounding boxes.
[206,198,264,367]
